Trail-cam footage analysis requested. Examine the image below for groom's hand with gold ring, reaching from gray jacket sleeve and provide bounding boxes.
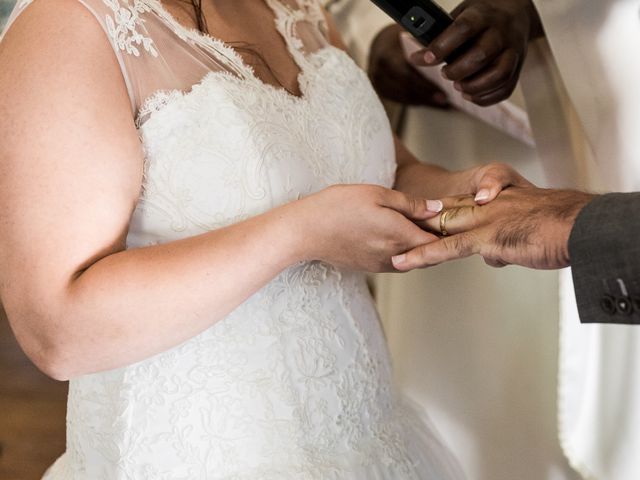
[393,187,594,271]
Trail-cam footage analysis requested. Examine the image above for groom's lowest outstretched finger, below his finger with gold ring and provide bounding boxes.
[391,233,479,272]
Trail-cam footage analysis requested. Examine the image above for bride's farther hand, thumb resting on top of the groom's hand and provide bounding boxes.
[450,163,534,205]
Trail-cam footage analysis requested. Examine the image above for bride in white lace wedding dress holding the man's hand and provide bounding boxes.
[0,0,518,480]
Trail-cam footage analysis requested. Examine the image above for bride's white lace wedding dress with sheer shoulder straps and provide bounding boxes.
[3,0,461,480]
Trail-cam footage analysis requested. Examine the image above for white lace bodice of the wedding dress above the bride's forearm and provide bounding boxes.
[129,47,395,245]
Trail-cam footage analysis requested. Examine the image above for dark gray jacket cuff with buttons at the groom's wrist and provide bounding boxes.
[569,193,640,324]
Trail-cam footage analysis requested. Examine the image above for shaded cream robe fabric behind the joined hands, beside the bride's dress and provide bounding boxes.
[330,0,579,480]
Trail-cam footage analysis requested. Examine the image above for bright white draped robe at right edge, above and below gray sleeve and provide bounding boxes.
[524,0,640,480]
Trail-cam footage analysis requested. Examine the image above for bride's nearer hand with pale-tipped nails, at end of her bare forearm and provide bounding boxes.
[290,185,442,272]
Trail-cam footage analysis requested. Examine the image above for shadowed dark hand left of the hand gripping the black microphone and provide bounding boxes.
[369,25,449,108]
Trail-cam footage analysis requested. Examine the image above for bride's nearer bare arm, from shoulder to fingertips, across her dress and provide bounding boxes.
[0,0,438,379]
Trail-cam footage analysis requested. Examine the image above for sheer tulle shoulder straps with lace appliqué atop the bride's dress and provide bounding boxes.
[0,0,336,121]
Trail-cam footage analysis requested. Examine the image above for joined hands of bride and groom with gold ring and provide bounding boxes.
[301,164,593,272]
